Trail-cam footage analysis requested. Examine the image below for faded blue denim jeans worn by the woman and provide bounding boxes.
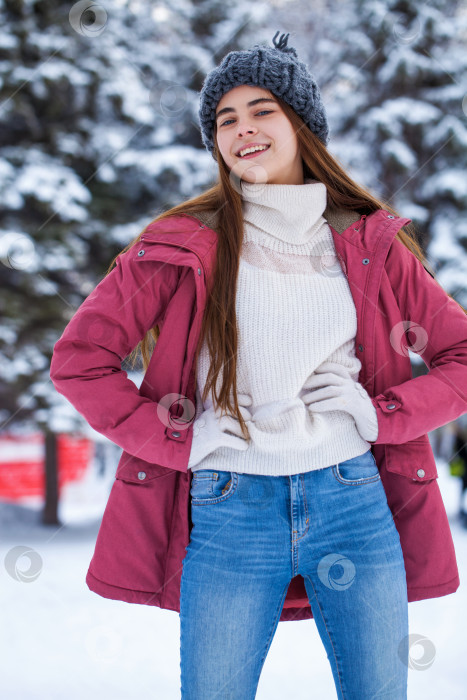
[180,450,409,700]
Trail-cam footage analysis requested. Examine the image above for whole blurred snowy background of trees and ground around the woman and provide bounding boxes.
[0,0,467,700]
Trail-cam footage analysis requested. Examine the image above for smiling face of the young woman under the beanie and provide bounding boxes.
[216,85,304,185]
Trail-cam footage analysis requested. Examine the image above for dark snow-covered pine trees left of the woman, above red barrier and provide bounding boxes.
[0,0,267,516]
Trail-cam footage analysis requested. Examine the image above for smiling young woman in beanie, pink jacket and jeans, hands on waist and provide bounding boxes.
[51,34,467,700]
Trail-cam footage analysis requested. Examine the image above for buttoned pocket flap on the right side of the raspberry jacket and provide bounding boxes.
[385,435,438,482]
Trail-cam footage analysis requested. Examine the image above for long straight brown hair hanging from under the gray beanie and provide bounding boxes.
[106,95,465,439]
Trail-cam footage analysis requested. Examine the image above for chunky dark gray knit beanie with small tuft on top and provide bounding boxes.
[199,31,329,159]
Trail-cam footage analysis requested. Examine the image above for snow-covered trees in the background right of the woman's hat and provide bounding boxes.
[272,0,467,306]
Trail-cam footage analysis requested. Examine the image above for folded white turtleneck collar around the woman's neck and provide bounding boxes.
[241,179,327,244]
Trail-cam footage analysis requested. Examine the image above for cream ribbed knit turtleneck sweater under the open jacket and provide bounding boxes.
[191,180,377,476]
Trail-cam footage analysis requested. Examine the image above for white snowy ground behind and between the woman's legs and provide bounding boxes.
[0,452,467,700]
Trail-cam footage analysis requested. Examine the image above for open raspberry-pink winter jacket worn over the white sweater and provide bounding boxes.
[50,208,467,621]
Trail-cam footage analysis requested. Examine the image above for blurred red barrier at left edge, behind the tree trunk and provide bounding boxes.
[0,433,94,501]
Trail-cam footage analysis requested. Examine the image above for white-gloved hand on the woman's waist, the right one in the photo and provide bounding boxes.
[302,362,378,442]
